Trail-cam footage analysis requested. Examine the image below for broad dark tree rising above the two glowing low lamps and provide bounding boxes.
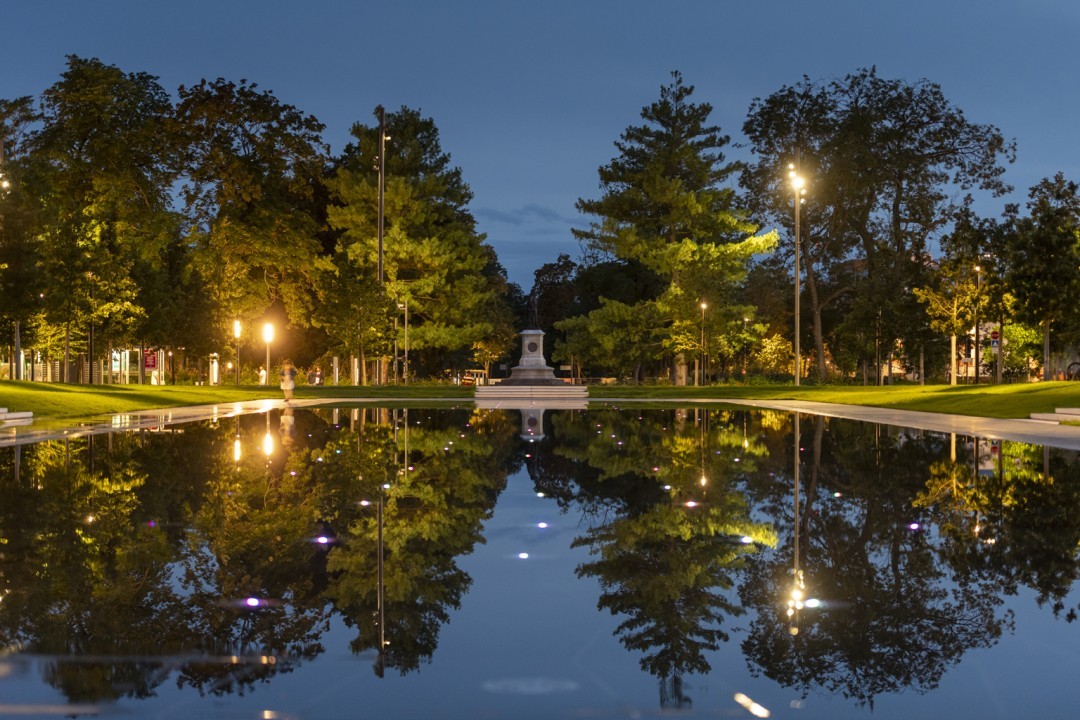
[175,79,327,339]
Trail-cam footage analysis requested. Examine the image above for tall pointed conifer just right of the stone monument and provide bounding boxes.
[573,72,775,386]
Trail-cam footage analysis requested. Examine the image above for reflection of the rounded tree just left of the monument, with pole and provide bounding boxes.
[320,412,517,675]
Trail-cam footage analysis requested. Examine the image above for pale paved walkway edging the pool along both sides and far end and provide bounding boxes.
[0,397,1080,450]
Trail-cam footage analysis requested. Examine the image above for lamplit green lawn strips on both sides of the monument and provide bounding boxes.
[0,381,1080,424]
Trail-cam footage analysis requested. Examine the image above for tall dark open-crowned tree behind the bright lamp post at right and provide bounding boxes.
[742,68,1015,379]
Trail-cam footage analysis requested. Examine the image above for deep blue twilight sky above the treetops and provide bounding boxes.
[0,0,1080,290]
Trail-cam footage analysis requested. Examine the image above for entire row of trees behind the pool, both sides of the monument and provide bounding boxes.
[0,56,1080,383]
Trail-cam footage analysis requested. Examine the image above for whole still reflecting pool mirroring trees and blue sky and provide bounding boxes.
[0,405,1080,720]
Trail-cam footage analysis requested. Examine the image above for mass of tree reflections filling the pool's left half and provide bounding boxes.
[0,411,522,702]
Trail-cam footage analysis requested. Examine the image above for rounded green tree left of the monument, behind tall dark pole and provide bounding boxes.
[328,107,507,375]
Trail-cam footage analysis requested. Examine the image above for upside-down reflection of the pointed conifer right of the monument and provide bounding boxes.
[548,410,774,707]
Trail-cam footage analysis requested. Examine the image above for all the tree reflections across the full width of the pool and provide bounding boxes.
[6,408,1080,707]
